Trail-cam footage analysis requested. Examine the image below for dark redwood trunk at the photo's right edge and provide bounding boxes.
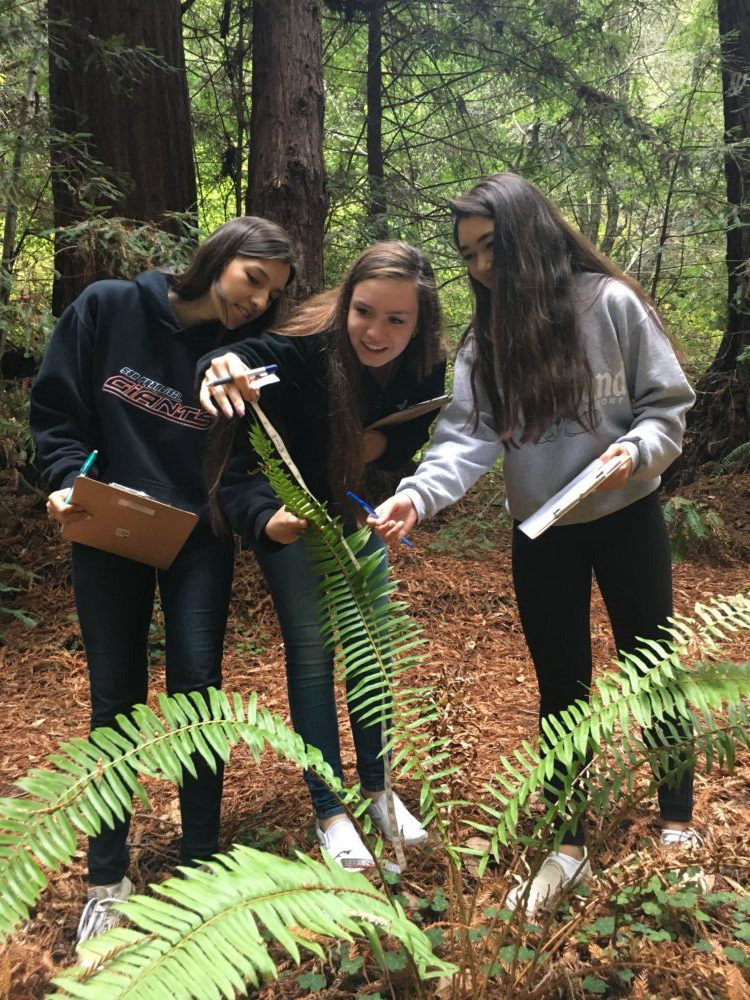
[670,0,750,481]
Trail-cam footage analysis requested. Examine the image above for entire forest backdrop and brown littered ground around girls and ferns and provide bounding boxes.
[0,0,750,1000]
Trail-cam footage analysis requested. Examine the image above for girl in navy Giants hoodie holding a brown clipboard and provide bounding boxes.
[31,216,294,943]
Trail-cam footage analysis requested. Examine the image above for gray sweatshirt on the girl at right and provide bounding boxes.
[398,273,695,524]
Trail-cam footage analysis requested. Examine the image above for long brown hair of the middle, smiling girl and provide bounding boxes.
[278,240,445,510]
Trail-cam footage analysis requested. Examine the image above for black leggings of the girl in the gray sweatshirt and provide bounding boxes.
[513,492,693,844]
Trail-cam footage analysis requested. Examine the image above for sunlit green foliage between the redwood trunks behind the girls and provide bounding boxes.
[0,0,726,360]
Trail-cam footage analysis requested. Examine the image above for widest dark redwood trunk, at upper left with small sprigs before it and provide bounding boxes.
[48,0,196,315]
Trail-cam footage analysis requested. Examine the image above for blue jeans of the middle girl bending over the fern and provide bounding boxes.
[256,534,386,819]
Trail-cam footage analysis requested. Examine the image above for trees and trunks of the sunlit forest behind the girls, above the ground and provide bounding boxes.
[0,0,748,488]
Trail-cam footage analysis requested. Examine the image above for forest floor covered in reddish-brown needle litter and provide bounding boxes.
[0,475,750,1000]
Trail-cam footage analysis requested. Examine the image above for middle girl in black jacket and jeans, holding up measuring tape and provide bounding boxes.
[199,242,445,867]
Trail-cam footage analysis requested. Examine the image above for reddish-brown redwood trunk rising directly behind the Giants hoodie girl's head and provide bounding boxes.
[247,0,328,299]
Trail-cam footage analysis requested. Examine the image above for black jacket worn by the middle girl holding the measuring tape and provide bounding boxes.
[198,333,445,547]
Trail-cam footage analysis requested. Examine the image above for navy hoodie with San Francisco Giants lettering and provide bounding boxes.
[30,271,239,517]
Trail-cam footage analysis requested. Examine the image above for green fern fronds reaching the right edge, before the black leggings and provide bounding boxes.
[471,594,750,855]
